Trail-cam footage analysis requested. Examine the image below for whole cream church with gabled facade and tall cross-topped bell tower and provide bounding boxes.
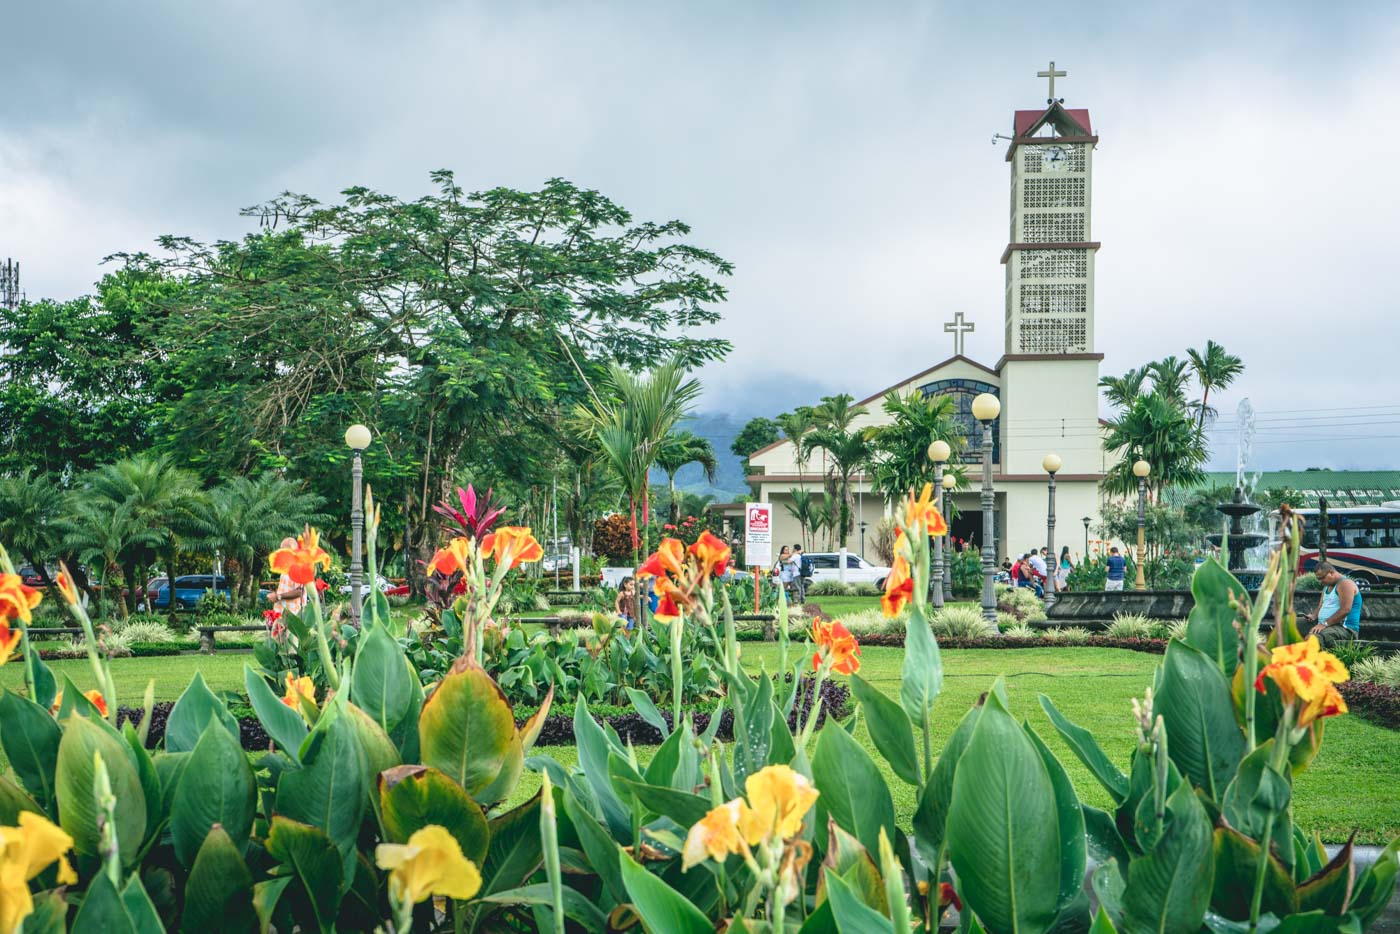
[748,63,1106,562]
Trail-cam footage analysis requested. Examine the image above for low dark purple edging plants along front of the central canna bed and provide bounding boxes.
[116,678,851,752]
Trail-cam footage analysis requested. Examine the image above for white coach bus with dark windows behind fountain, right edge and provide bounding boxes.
[1294,501,1400,590]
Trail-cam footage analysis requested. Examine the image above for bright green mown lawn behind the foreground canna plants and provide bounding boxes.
[13,646,1400,843]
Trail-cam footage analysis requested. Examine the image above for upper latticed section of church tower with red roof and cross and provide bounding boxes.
[1001,62,1099,356]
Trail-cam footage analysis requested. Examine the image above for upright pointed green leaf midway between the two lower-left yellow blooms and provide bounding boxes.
[171,716,258,867]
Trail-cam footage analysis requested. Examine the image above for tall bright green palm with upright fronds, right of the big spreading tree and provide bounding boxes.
[578,360,700,559]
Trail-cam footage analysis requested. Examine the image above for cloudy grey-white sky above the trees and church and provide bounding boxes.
[0,0,1400,468]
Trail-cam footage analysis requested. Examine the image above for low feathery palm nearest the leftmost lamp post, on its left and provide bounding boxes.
[190,473,322,601]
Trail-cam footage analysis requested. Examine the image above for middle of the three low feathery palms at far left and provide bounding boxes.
[84,455,202,620]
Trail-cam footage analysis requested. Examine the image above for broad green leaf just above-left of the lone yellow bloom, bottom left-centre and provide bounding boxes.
[275,708,367,875]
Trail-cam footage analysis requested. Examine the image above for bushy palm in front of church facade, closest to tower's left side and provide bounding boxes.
[865,391,967,512]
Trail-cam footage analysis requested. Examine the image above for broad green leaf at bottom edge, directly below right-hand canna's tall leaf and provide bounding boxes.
[1123,783,1214,934]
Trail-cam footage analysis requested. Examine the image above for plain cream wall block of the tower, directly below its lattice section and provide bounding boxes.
[1001,360,1103,473]
